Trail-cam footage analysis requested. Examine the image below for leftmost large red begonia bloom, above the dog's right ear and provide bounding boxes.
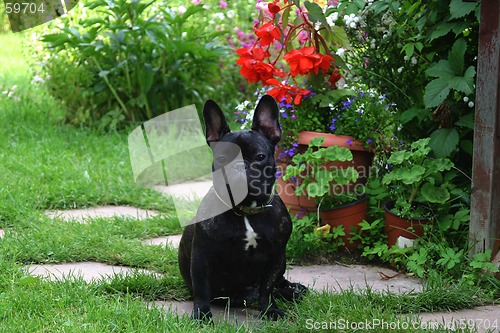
[236,47,285,84]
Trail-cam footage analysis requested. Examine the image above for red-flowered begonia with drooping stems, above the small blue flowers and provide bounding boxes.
[236,0,348,105]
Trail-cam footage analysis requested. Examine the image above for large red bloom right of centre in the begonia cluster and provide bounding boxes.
[283,46,333,76]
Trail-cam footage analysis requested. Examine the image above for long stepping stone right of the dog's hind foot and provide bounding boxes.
[285,265,422,294]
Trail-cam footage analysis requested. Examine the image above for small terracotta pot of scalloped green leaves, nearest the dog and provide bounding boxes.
[283,137,368,249]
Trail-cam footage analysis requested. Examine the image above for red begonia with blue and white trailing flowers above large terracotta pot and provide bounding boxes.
[236,0,393,150]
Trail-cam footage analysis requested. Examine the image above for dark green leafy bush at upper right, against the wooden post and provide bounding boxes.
[339,0,479,165]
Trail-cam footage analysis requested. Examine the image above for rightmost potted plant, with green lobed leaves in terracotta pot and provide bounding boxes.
[382,138,453,247]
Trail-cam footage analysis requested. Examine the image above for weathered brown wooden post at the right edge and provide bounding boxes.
[469,0,500,256]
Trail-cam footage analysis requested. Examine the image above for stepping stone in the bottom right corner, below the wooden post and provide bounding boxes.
[419,305,500,333]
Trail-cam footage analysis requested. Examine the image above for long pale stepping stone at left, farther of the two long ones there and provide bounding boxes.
[45,206,158,222]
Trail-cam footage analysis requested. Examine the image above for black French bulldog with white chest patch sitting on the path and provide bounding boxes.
[179,95,306,320]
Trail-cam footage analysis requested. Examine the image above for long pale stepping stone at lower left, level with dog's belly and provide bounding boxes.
[26,262,157,282]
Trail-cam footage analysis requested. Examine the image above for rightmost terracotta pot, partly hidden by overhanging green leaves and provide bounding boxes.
[384,201,429,248]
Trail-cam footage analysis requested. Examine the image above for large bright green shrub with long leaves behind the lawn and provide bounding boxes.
[32,0,231,128]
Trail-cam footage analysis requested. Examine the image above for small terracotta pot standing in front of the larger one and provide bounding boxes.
[320,197,368,250]
